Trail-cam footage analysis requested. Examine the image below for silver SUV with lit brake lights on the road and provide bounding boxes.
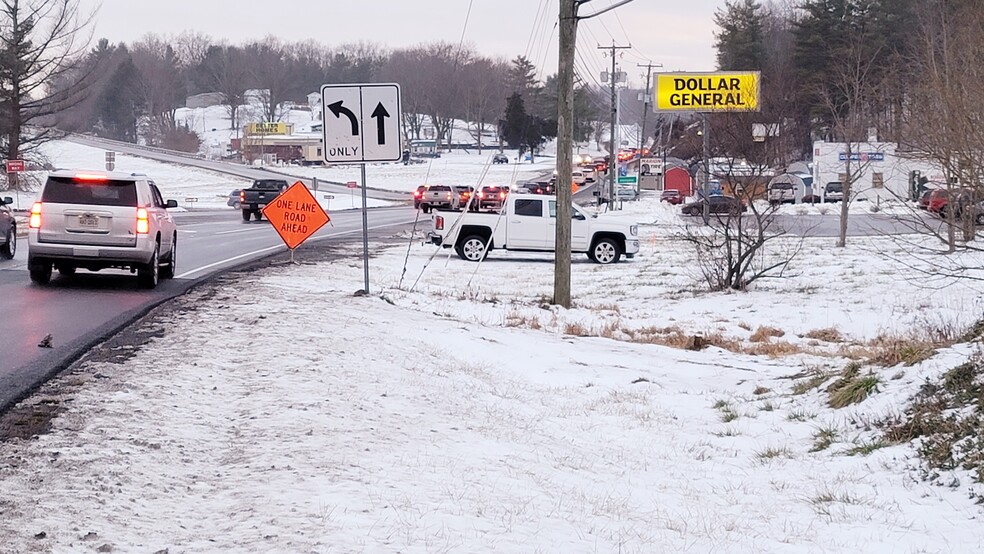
[27,170,178,289]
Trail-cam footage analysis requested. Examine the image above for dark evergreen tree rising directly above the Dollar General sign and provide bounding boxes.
[714,0,765,71]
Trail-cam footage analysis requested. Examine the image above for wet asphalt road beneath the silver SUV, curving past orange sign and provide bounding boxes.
[0,207,416,412]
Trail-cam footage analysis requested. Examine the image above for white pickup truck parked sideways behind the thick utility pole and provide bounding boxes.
[428,194,639,264]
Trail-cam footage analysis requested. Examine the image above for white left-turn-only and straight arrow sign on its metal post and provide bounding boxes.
[321,83,403,294]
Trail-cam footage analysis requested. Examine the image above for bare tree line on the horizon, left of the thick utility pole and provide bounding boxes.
[0,0,598,176]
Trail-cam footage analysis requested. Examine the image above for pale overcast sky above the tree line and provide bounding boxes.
[79,0,724,84]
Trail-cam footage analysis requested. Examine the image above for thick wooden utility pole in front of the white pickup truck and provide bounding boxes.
[553,0,632,308]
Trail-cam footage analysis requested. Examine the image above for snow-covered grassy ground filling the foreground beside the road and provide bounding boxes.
[0,152,984,553]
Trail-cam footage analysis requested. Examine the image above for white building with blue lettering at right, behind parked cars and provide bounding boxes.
[813,141,946,200]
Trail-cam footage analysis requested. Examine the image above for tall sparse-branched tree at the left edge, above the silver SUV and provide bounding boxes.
[0,0,92,188]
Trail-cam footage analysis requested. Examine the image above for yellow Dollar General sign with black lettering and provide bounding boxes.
[653,71,759,112]
